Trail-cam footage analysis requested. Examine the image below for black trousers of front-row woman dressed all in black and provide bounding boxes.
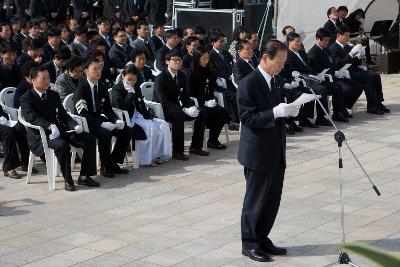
[200,106,231,144]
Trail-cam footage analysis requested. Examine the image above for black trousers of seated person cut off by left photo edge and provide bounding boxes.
[0,123,29,172]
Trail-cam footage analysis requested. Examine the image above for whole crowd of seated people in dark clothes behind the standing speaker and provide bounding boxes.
[0,1,390,191]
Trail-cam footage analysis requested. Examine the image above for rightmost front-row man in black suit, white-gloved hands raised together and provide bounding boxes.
[329,25,390,115]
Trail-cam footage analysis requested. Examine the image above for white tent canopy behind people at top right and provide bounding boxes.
[276,0,399,50]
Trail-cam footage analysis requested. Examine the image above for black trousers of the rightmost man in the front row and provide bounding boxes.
[350,69,384,107]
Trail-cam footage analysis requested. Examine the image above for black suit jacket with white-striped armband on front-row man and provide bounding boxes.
[73,79,118,127]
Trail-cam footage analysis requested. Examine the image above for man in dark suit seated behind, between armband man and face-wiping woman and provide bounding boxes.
[108,28,131,69]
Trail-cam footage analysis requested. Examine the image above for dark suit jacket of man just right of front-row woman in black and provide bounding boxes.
[208,49,233,80]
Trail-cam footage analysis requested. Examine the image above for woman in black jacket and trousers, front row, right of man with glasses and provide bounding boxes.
[186,47,231,150]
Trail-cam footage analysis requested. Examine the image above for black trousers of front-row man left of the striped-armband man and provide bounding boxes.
[47,132,97,183]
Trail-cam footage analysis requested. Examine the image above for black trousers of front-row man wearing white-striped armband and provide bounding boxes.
[89,125,132,167]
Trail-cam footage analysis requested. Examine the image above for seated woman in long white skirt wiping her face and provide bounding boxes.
[111,64,172,167]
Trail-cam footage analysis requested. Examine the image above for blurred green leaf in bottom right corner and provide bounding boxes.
[342,244,400,267]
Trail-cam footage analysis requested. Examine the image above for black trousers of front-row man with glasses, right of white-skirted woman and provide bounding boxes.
[164,106,207,153]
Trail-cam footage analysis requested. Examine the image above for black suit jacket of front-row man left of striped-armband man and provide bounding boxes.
[20,88,78,156]
